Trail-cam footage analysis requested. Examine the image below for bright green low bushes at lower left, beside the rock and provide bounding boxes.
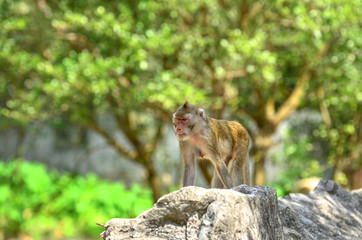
[0,159,153,239]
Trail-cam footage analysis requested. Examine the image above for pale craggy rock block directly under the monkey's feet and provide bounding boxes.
[99,185,283,240]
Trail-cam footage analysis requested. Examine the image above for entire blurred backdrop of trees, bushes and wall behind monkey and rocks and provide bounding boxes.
[0,0,362,239]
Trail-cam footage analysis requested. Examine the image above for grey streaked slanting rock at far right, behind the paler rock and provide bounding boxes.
[278,180,362,239]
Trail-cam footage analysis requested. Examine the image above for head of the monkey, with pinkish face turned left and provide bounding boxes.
[172,101,206,141]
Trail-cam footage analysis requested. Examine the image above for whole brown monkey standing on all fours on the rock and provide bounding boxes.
[172,101,251,188]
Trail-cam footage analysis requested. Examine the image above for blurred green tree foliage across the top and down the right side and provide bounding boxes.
[0,0,362,210]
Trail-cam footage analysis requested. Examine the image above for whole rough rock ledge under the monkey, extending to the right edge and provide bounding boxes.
[101,180,362,240]
